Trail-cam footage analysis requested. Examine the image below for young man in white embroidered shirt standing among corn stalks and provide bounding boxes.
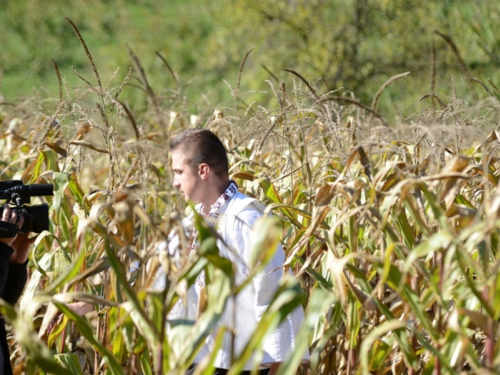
[157,129,308,374]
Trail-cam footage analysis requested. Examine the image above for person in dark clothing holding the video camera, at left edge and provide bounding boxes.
[0,204,36,375]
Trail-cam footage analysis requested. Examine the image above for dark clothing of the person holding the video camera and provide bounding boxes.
[0,242,28,375]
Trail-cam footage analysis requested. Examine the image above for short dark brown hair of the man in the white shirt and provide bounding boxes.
[170,129,229,177]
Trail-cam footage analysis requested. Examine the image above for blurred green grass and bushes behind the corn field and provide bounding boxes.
[0,0,500,118]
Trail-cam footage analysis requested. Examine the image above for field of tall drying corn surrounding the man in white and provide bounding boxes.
[0,22,500,375]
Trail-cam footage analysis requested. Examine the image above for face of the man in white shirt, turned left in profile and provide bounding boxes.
[172,148,203,203]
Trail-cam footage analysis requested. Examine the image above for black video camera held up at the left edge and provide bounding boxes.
[0,180,54,238]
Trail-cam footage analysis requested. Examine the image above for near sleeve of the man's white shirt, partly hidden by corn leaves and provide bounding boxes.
[229,208,288,363]
